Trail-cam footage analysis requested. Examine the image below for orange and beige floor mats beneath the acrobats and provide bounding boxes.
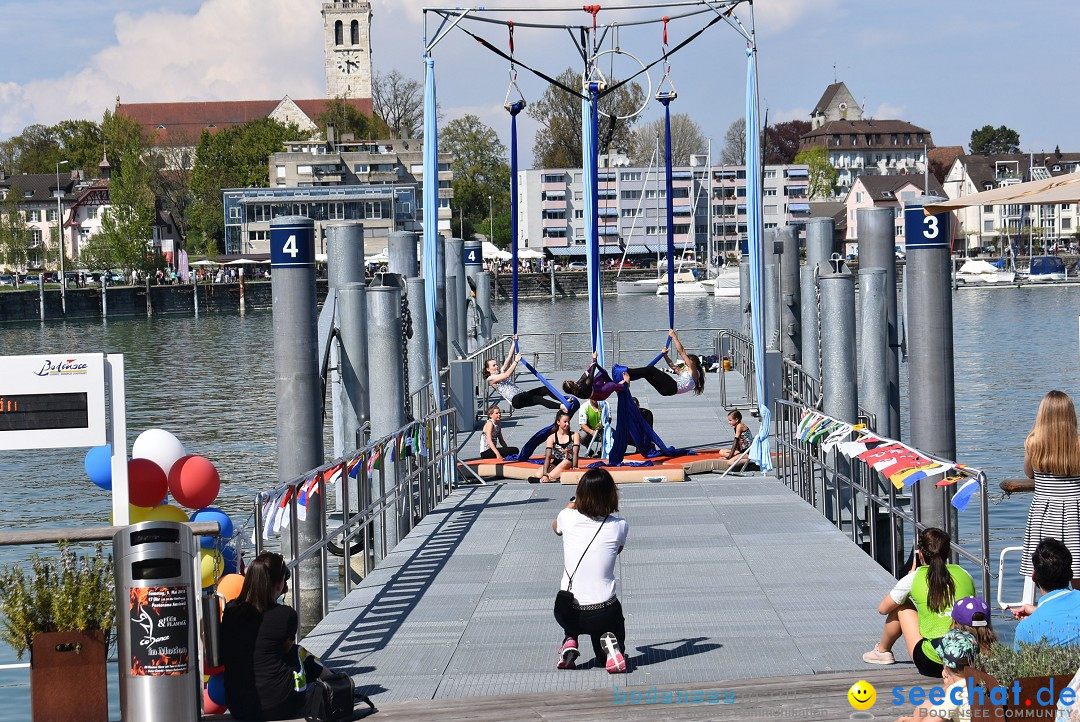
[467,449,747,485]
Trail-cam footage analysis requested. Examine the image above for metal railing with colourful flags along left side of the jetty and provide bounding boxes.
[254,405,457,635]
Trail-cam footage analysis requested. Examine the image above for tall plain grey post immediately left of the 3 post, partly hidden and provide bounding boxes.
[855,208,900,439]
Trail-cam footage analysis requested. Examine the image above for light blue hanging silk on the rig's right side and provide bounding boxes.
[746,46,772,472]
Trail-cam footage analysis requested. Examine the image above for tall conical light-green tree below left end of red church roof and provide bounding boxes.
[82,138,154,272]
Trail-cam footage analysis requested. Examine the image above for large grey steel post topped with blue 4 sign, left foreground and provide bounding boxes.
[270,216,324,635]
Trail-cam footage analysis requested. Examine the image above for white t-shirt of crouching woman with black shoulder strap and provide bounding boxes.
[555,509,630,604]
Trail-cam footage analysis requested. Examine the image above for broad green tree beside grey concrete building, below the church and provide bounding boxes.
[188,118,300,256]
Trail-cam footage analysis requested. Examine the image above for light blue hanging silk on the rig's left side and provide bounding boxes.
[423,53,443,411]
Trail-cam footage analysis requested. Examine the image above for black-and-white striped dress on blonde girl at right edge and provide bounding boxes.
[1020,472,1080,578]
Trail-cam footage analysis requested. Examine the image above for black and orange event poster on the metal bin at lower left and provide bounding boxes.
[129,586,190,677]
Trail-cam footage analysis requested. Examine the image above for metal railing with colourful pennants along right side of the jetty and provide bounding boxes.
[774,400,991,598]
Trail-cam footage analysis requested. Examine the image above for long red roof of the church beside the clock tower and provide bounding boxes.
[116,98,374,146]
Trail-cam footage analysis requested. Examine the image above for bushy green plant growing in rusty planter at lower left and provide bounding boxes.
[0,543,116,659]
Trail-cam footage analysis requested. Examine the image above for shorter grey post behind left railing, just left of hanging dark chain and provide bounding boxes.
[367,286,411,562]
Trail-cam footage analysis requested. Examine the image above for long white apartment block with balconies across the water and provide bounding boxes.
[516,155,810,258]
